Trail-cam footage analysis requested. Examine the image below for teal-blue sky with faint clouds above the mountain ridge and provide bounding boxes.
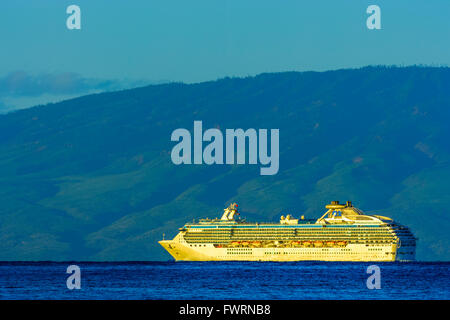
[0,0,450,109]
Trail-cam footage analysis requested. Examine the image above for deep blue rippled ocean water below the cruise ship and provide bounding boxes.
[0,262,450,300]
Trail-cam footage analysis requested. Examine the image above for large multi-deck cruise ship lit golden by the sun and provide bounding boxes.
[159,201,416,261]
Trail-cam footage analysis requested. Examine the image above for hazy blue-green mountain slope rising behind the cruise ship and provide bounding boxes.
[0,67,450,260]
